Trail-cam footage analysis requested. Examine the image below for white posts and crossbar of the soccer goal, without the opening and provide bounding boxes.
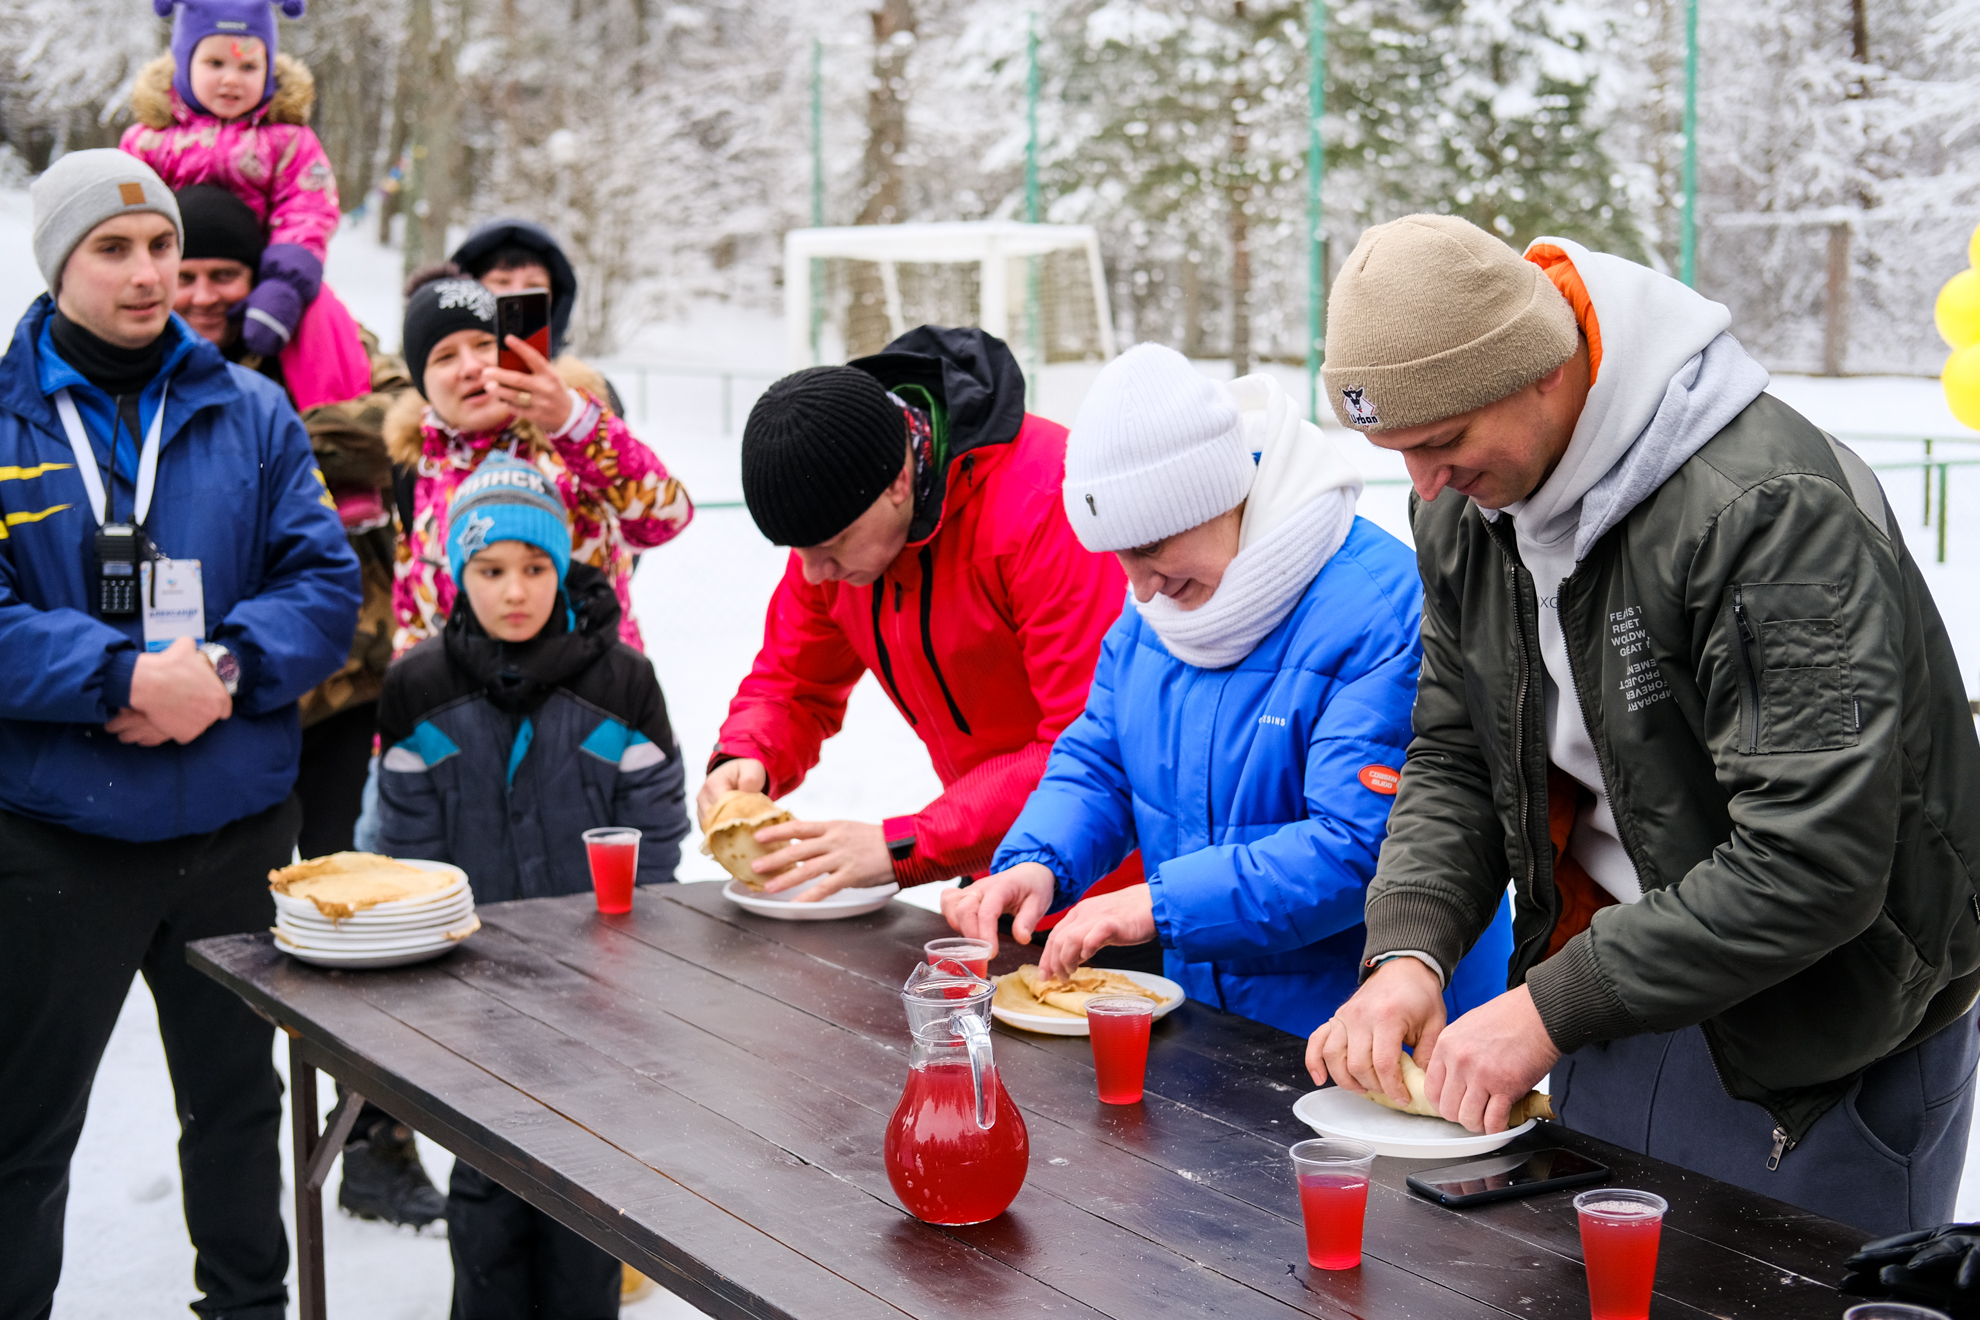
[784,220,1119,368]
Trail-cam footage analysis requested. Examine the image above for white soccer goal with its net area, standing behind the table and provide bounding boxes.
[784,220,1115,374]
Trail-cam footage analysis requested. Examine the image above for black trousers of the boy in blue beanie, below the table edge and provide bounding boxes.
[447,1160,624,1320]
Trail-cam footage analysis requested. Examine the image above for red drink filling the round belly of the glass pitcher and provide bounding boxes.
[887,1059,1032,1225]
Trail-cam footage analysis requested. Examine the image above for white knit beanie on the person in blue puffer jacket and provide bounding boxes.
[1065,344,1257,552]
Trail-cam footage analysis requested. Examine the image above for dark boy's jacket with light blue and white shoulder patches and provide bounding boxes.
[378,564,687,902]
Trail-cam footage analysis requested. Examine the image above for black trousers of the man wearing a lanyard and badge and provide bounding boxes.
[0,798,299,1320]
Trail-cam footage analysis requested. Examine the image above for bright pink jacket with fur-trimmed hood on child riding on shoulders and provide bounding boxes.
[119,55,341,261]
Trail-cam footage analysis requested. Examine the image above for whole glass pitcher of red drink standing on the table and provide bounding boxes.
[887,960,1032,1225]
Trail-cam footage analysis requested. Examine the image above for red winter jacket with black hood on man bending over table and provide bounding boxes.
[711,327,1127,885]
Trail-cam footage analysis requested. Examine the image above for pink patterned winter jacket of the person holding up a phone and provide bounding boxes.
[386,374,695,657]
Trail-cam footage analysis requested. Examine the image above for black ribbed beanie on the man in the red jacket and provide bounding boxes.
[743,366,907,546]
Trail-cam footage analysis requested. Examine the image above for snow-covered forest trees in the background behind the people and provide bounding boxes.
[0,0,1980,374]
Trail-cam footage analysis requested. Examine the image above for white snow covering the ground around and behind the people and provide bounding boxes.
[23,201,1980,1320]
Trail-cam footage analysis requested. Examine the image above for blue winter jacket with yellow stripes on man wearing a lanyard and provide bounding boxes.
[0,295,358,841]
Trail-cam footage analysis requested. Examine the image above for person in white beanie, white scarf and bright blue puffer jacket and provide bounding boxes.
[944,344,1511,1035]
